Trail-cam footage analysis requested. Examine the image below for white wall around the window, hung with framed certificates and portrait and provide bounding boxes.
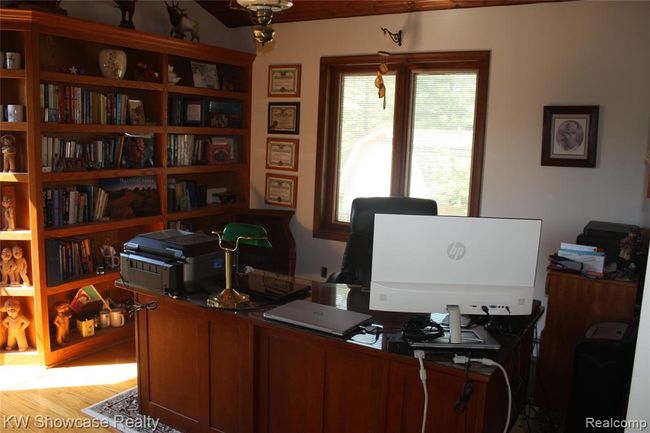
[251,1,650,299]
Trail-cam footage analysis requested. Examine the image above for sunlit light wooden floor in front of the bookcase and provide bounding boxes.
[0,342,137,433]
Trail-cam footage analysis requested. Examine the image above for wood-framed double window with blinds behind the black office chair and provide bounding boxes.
[314,51,489,240]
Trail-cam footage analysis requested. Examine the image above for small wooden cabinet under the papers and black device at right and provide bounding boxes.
[535,271,638,418]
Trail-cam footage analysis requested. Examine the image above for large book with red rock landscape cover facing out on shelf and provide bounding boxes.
[100,176,160,219]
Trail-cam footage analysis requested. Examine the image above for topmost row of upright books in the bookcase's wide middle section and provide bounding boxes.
[40,83,129,125]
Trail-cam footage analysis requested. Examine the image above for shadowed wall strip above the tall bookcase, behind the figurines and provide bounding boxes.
[61,0,255,52]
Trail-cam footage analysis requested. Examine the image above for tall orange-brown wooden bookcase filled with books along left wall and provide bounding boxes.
[0,9,254,365]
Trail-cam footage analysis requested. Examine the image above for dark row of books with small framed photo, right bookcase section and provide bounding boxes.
[167,95,244,128]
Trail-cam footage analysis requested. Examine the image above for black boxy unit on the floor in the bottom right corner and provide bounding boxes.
[565,322,637,433]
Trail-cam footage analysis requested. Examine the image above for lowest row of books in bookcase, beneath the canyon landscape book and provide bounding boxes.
[45,238,96,286]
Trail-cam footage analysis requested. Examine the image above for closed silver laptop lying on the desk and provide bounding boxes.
[264,300,372,337]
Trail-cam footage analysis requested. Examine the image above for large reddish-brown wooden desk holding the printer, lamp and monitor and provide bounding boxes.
[129,285,541,433]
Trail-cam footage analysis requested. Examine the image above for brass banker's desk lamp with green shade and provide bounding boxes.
[208,223,271,308]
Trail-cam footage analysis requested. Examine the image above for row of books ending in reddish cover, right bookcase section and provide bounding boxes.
[167,134,239,167]
